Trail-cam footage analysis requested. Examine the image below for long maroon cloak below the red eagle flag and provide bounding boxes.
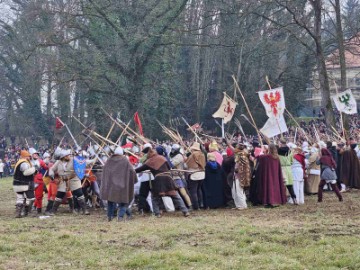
[253,155,286,205]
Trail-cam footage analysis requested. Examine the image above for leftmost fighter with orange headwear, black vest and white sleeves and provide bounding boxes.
[13,150,36,218]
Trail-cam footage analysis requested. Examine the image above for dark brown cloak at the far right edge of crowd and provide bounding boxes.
[340,149,360,188]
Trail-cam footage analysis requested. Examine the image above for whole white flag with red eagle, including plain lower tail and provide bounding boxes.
[259,87,288,138]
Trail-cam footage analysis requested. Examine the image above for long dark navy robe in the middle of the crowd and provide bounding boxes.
[203,162,225,208]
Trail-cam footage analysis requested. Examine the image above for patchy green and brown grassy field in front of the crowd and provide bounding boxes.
[0,179,360,269]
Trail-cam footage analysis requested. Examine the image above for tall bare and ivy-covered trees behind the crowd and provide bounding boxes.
[0,0,360,140]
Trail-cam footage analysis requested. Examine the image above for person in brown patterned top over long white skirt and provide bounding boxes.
[231,144,251,210]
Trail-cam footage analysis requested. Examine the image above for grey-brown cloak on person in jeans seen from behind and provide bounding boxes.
[100,155,137,203]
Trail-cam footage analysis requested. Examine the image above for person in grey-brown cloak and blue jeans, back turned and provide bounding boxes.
[100,147,137,221]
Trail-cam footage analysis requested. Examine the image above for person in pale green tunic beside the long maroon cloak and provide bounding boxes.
[278,139,298,204]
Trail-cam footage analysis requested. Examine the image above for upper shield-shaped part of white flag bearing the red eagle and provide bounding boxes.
[258,87,285,118]
